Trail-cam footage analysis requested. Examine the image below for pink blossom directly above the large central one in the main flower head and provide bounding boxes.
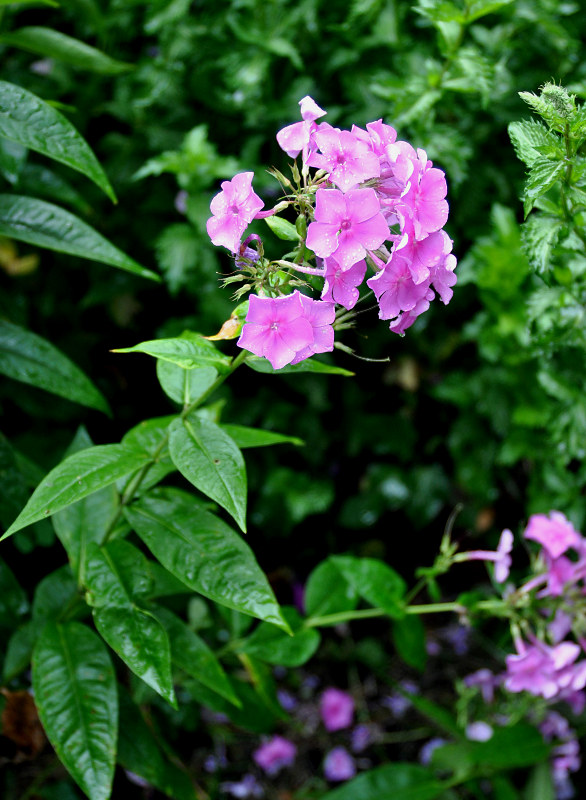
[307,128,380,192]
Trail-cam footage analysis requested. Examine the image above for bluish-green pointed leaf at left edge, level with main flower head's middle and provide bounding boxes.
[0,193,161,282]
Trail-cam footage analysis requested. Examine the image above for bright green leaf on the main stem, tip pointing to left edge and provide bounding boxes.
[1,444,149,539]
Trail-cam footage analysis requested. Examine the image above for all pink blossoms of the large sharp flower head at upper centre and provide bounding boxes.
[207,96,456,369]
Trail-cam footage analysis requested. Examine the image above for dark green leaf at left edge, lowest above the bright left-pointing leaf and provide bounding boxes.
[0,319,110,414]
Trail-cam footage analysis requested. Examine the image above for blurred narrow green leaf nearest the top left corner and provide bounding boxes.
[0,25,133,75]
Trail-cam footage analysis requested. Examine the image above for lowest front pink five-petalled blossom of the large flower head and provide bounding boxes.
[237,292,314,369]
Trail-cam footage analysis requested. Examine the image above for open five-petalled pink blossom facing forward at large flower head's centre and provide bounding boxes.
[306,189,389,270]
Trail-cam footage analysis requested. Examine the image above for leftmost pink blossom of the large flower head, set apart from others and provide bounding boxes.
[206,172,264,253]
